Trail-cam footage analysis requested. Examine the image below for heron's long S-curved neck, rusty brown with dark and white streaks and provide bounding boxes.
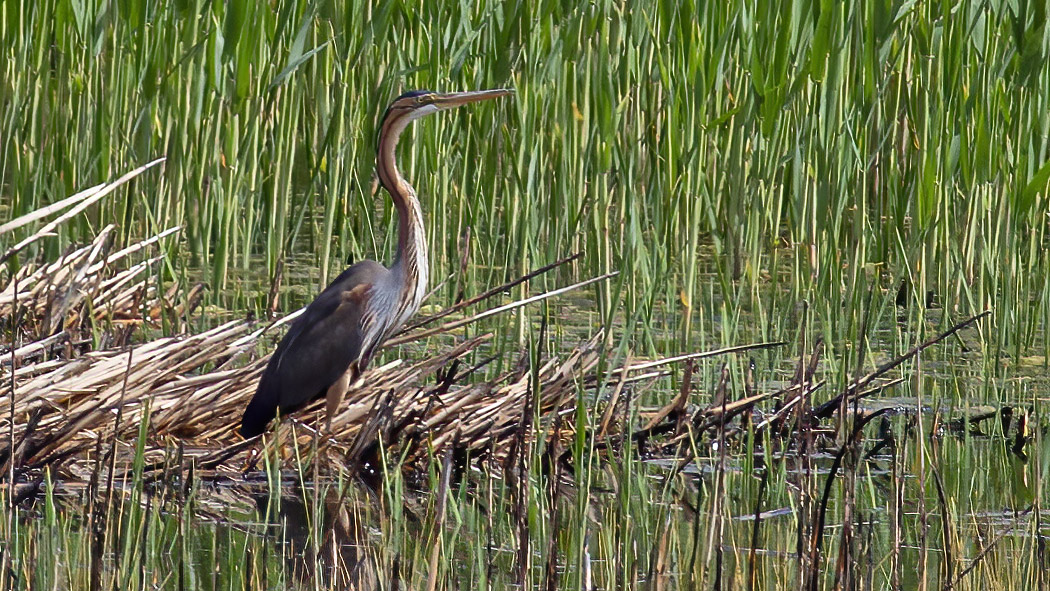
[376,111,429,314]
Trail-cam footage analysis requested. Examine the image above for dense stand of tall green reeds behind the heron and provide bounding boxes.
[0,2,1050,363]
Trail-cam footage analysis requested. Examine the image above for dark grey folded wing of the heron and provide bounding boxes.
[240,260,390,438]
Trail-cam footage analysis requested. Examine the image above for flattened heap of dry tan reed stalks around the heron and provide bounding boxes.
[0,215,621,477]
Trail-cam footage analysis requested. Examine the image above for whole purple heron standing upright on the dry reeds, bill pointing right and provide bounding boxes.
[240,89,511,438]
